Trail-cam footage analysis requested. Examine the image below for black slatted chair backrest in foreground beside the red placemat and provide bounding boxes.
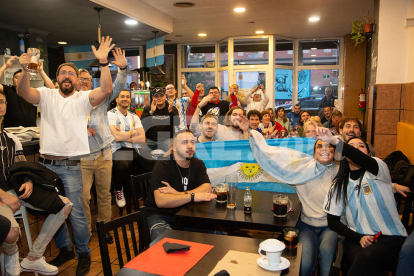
[96,207,151,276]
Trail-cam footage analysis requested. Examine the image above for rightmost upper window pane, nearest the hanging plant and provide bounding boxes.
[298,39,339,65]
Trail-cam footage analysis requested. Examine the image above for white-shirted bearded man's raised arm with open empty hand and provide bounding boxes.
[89,36,115,106]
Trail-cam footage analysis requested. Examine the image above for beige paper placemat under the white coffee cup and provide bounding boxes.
[208,250,281,276]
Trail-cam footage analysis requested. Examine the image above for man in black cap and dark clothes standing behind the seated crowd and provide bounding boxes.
[141,87,180,152]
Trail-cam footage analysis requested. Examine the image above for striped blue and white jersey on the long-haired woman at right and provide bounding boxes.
[324,157,407,236]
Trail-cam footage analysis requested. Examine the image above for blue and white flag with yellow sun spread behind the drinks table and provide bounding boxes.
[196,135,316,193]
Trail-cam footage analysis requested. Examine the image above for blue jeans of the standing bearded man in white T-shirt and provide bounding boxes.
[41,163,91,256]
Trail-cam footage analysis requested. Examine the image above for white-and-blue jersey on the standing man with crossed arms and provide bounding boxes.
[108,107,142,153]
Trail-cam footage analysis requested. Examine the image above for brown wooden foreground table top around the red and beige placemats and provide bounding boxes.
[115,230,302,276]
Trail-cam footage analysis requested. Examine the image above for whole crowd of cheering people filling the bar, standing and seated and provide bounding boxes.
[0,37,414,276]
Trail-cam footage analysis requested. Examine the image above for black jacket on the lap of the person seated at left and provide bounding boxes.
[10,161,65,214]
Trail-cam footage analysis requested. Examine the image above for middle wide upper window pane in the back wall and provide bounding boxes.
[233,38,269,65]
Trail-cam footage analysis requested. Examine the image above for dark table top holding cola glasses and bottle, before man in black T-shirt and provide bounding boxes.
[175,189,302,232]
